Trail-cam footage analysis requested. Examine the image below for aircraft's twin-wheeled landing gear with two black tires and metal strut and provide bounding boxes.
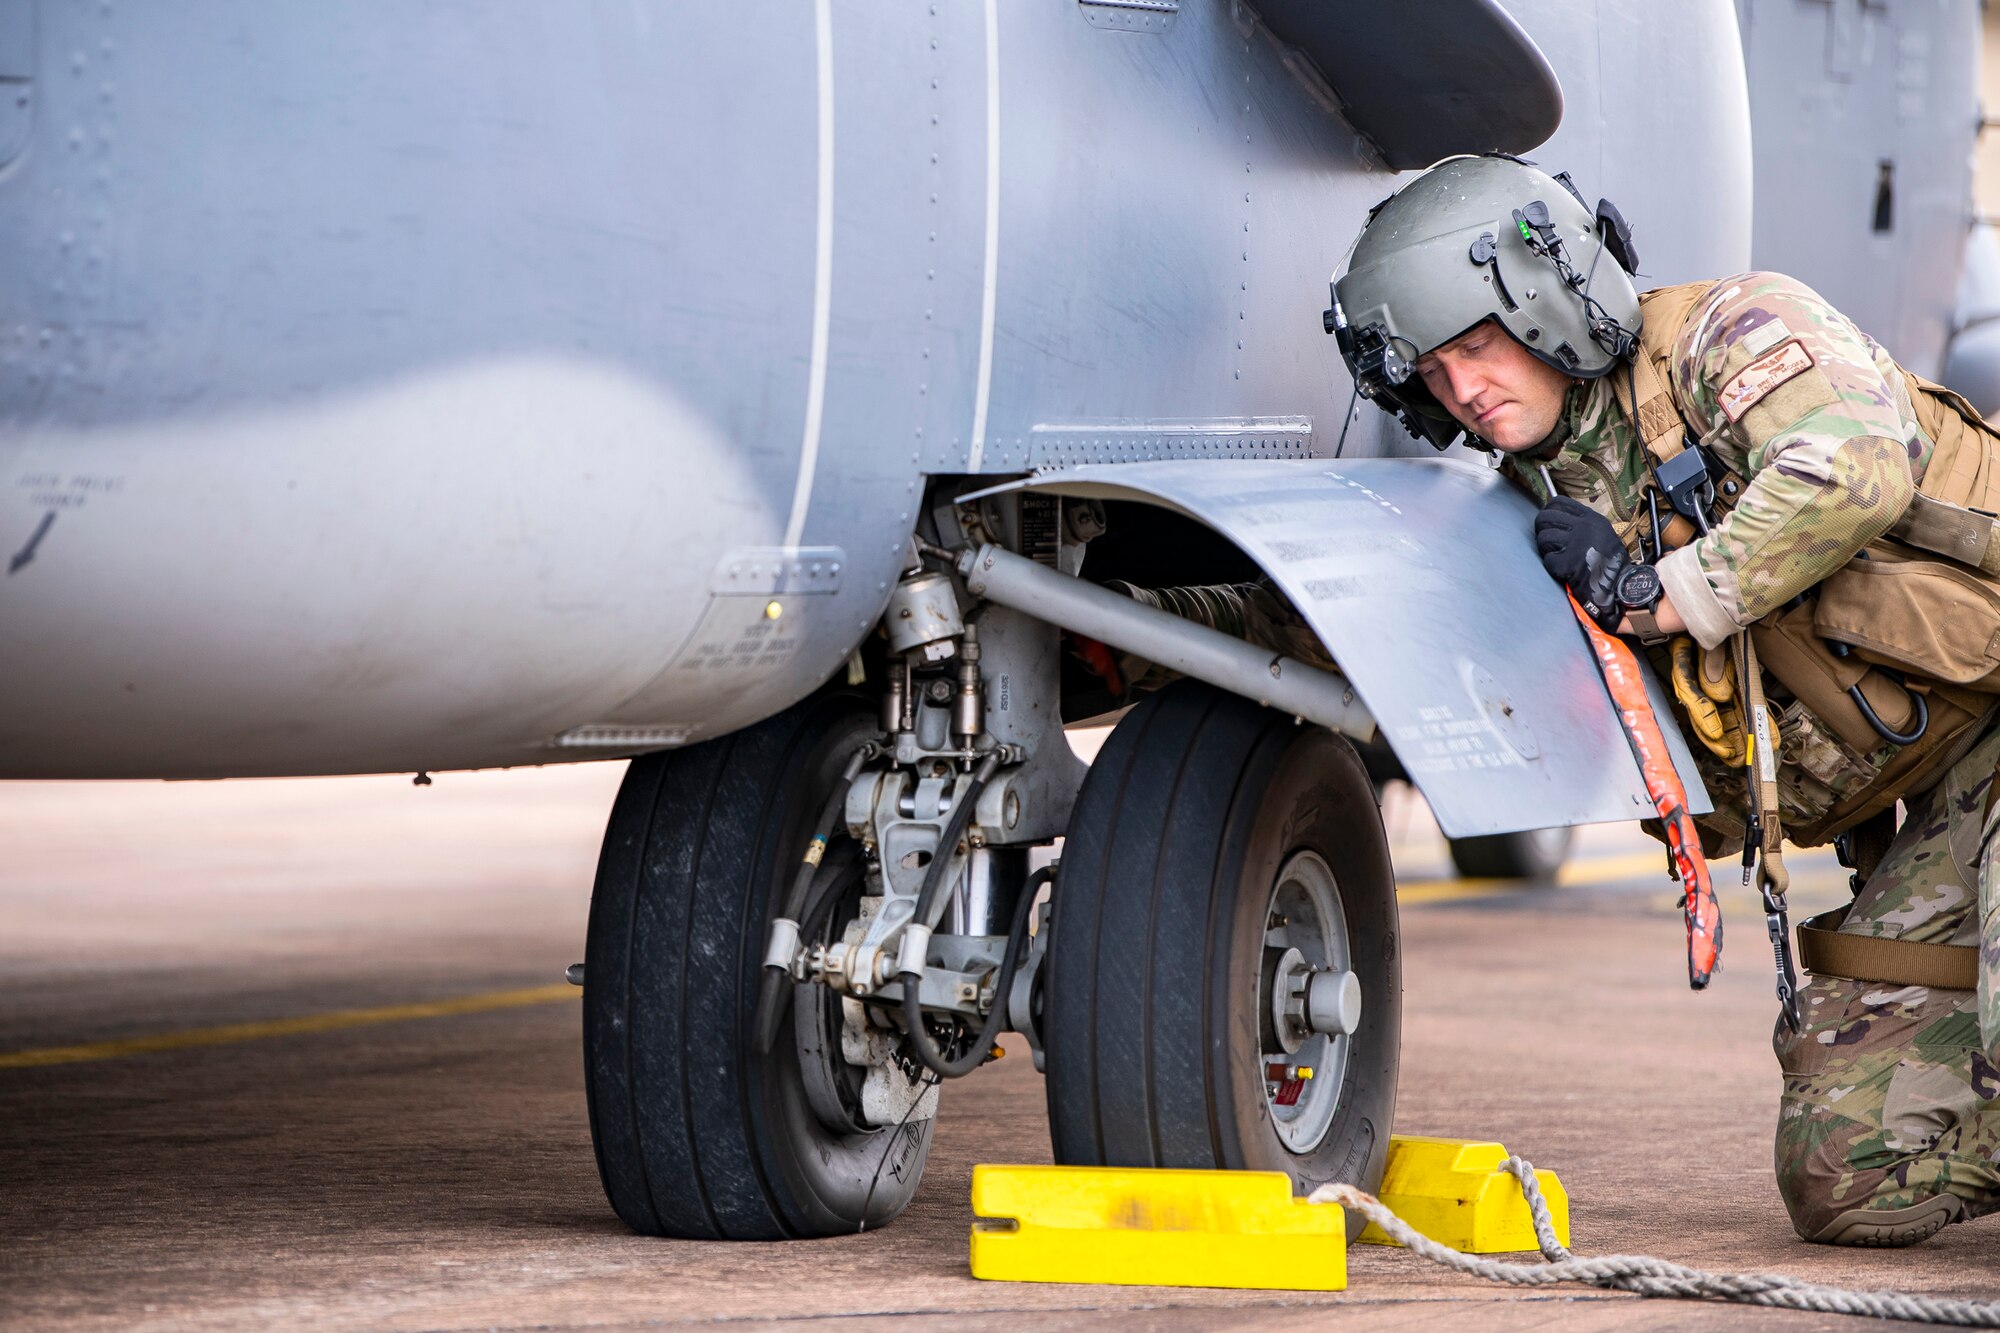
[584,496,1402,1239]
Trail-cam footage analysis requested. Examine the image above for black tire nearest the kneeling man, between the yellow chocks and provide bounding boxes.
[1042,681,1402,1231]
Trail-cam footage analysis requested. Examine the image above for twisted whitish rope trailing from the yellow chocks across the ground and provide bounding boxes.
[1308,1157,2000,1329]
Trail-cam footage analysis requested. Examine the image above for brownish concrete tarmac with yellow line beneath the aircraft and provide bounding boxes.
[0,765,2000,1331]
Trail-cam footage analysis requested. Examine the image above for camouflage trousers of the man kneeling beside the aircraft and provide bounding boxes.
[1772,729,2000,1245]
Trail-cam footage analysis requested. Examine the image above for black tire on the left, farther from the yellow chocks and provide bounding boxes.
[584,695,932,1241]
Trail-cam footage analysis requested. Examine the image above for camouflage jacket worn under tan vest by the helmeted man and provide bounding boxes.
[1500,274,1930,855]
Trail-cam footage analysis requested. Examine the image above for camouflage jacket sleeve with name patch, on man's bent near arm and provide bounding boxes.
[1660,272,1926,646]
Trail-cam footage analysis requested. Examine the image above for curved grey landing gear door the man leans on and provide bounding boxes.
[1028,458,1712,839]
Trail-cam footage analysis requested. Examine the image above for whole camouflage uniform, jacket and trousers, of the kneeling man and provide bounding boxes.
[1138,272,2000,1243]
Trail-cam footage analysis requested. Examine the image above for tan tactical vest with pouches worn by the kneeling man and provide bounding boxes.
[1612,282,2000,847]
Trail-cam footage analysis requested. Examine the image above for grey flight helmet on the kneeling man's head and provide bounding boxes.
[1326,154,1640,448]
